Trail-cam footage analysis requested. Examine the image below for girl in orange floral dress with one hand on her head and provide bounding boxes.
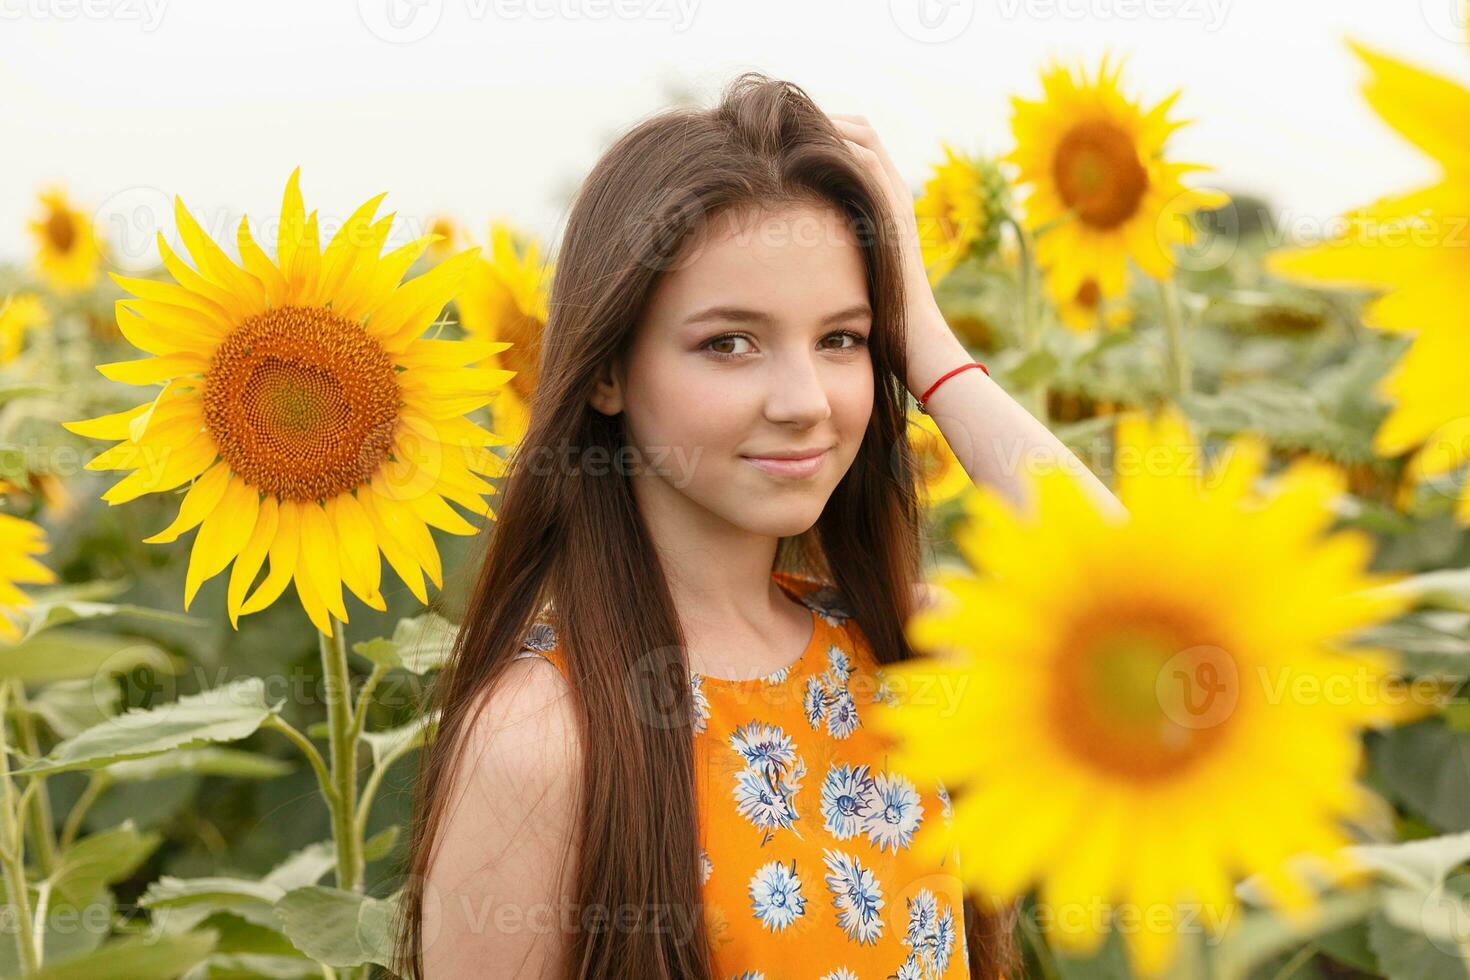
[398,73,1117,980]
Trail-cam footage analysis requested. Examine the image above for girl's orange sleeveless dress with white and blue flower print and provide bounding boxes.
[517,572,970,980]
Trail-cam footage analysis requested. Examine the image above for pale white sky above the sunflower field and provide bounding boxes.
[0,0,1470,264]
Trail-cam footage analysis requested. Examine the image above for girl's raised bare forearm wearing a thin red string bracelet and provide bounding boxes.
[907,307,1127,517]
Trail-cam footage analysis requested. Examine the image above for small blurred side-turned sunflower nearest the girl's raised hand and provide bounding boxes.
[914,144,1010,285]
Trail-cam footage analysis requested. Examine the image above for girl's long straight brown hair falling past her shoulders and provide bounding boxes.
[385,72,1017,980]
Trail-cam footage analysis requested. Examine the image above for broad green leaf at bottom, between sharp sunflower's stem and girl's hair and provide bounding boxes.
[276,884,394,967]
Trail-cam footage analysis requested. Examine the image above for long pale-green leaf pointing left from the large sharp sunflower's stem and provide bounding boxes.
[18,677,282,774]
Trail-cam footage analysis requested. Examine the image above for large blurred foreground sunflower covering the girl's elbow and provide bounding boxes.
[873,408,1423,974]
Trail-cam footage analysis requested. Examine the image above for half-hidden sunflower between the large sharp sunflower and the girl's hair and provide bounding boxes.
[456,222,554,442]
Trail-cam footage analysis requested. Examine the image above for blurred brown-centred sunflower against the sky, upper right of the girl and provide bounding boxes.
[1007,57,1229,306]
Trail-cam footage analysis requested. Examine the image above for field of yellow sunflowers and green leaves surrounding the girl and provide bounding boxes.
[0,26,1470,980]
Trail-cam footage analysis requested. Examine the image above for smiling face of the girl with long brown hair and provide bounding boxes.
[592,204,873,536]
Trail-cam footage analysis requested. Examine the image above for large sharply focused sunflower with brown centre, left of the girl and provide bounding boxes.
[65,170,510,635]
